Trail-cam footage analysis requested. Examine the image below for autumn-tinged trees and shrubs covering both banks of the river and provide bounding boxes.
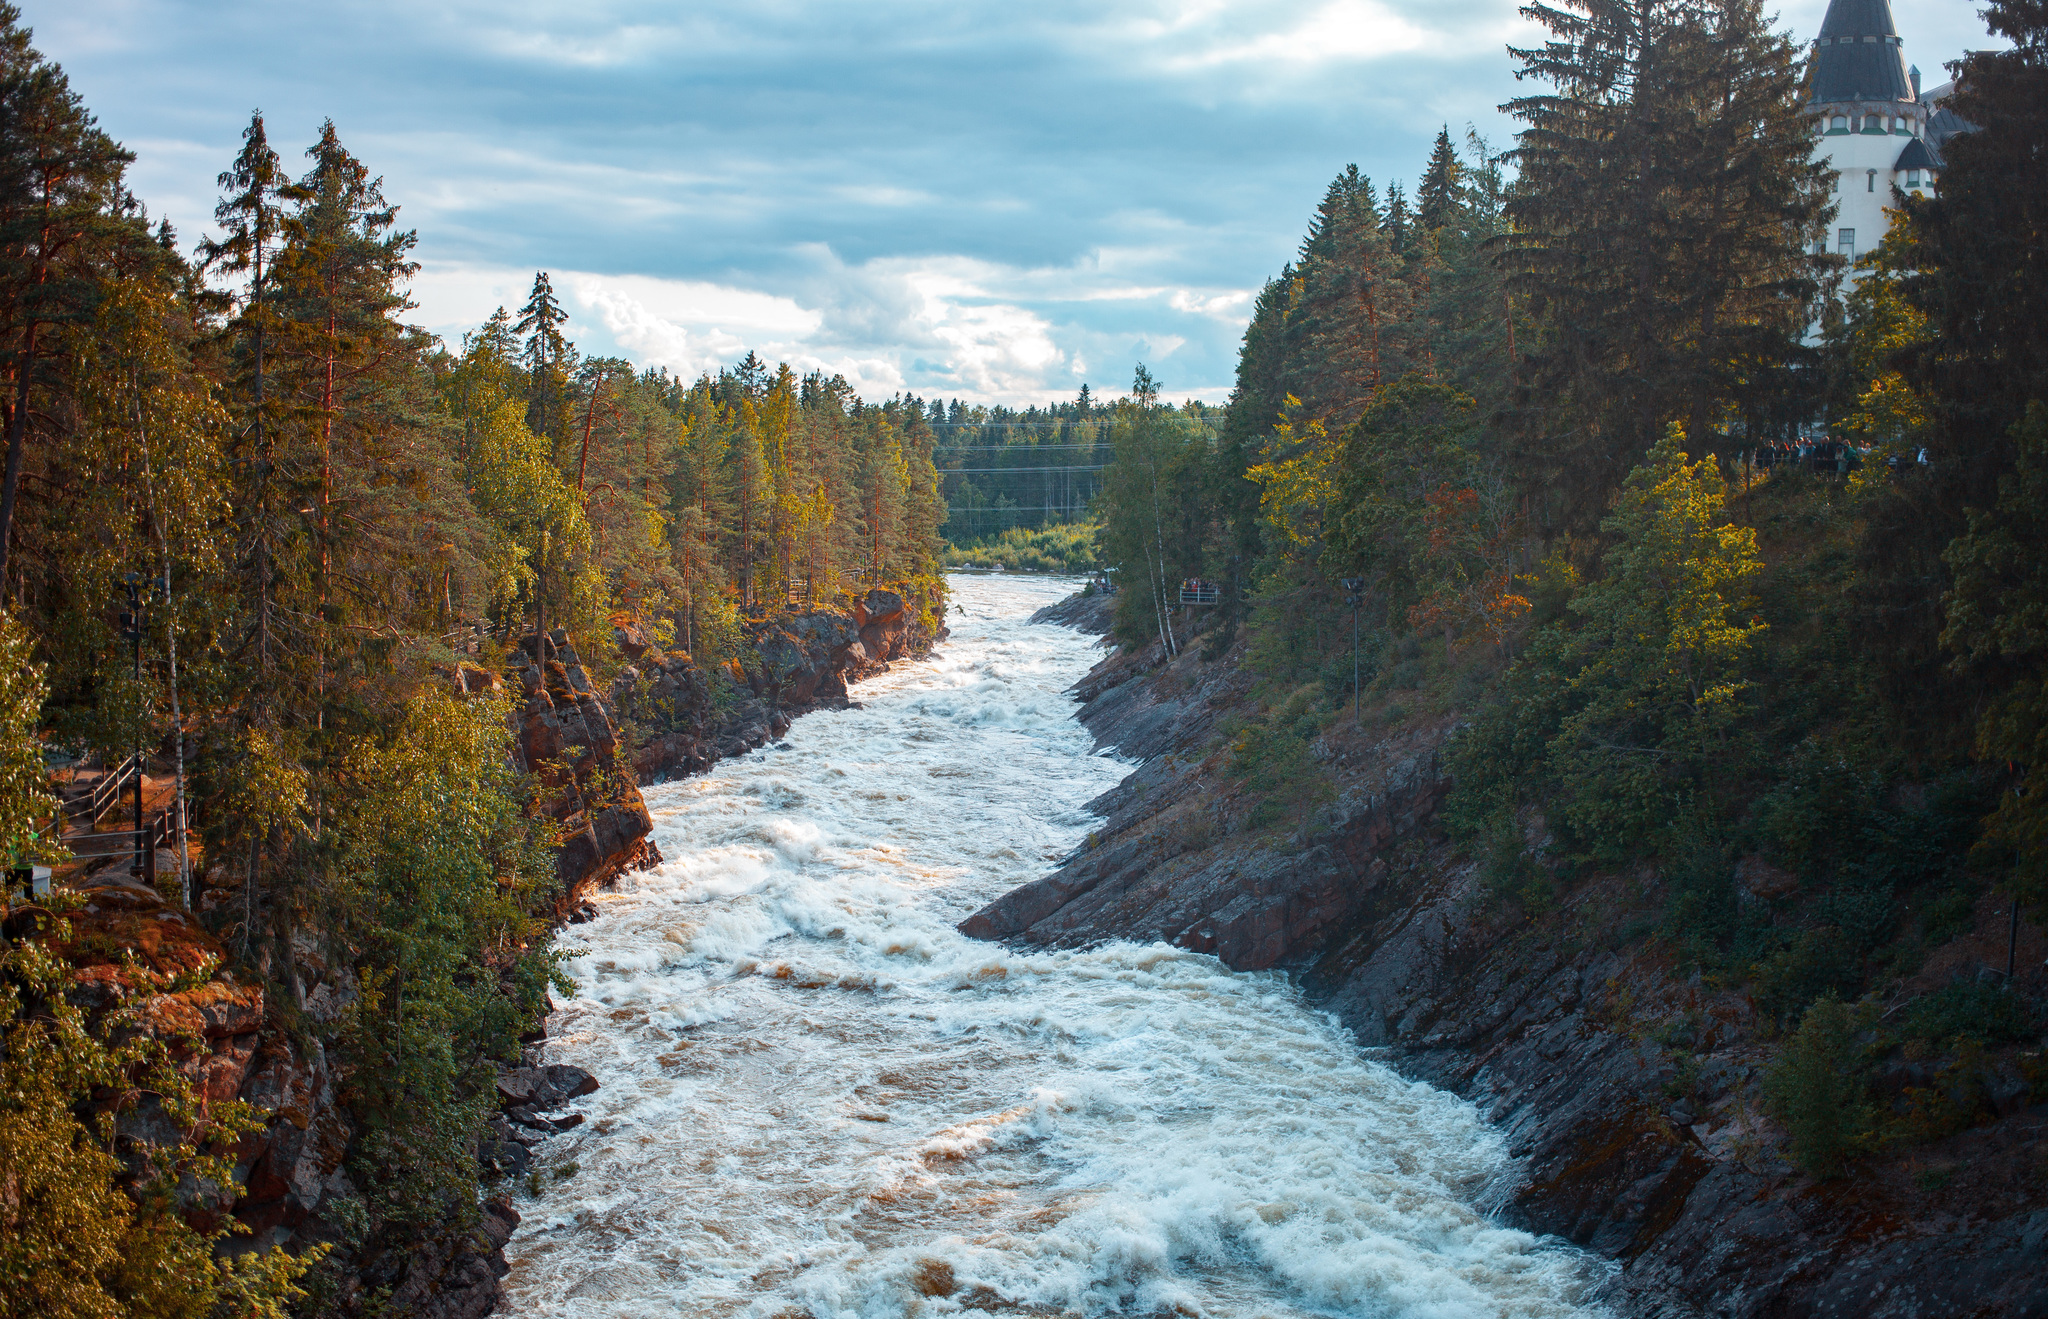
[0,0,2048,1315]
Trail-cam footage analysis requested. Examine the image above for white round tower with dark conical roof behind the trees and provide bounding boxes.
[1806,0,1942,260]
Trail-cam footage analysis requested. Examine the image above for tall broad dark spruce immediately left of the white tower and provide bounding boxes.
[1505,0,1829,526]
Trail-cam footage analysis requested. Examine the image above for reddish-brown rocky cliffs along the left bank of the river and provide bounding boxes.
[28,590,944,1319]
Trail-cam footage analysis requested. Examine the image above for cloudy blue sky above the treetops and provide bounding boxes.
[16,0,2003,406]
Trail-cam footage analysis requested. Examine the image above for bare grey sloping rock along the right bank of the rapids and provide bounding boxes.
[961,602,2048,1319]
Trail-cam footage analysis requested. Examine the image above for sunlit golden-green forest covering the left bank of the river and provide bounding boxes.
[0,6,944,1317]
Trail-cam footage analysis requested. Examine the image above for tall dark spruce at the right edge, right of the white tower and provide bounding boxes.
[1901,0,2048,920]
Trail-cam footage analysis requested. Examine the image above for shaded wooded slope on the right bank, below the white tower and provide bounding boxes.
[1007,0,2048,1313]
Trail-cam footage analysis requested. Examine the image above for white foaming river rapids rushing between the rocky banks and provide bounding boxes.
[508,578,1585,1319]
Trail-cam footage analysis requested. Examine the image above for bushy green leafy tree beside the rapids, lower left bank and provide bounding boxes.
[334,690,555,1225]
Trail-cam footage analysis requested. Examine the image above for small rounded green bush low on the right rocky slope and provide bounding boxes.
[1763,997,1876,1178]
